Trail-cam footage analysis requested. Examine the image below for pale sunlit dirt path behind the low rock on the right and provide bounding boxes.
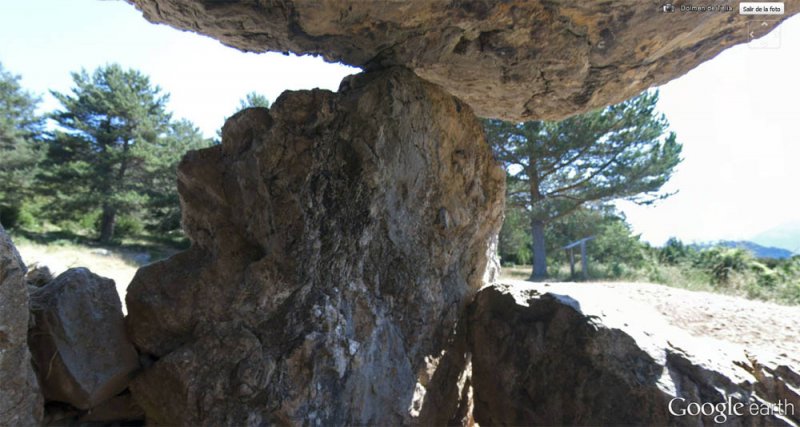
[500,279,800,367]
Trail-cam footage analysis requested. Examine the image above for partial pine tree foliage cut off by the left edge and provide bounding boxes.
[0,64,44,228]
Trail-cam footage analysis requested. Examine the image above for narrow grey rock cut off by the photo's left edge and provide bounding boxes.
[0,225,44,426]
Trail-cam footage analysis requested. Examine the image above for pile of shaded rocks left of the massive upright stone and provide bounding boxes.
[0,228,144,426]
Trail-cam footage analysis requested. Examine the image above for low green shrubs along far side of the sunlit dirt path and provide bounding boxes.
[500,219,800,304]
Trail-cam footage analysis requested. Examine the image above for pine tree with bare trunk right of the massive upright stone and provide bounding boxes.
[485,91,681,279]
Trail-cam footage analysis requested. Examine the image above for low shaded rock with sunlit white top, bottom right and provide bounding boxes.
[468,285,800,425]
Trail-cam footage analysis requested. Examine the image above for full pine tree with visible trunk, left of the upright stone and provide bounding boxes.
[43,64,170,242]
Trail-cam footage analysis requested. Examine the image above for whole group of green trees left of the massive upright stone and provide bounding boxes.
[0,64,209,244]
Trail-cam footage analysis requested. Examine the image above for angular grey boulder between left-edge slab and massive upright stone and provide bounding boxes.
[29,268,139,410]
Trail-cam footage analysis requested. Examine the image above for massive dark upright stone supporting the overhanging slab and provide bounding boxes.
[127,68,505,425]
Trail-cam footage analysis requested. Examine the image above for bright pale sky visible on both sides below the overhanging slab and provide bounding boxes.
[0,0,800,245]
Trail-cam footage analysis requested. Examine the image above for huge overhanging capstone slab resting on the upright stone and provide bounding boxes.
[128,0,800,120]
